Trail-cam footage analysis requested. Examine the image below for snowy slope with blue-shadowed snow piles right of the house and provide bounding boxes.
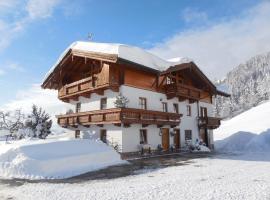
[214,102,270,152]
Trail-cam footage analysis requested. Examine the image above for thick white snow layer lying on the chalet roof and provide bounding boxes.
[44,41,190,81]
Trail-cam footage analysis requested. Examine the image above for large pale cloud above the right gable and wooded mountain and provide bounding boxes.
[150,2,270,78]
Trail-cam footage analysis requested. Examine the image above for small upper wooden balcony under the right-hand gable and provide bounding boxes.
[165,83,203,100]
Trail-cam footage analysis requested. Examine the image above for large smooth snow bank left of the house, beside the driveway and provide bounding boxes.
[0,138,125,179]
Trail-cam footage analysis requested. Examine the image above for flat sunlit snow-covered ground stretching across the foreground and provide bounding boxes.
[0,155,270,200]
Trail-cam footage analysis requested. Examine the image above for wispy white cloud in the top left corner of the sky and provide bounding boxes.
[0,0,61,52]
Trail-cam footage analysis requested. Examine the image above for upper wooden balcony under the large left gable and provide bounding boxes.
[58,76,119,101]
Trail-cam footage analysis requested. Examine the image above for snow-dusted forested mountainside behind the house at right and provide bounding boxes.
[215,52,270,118]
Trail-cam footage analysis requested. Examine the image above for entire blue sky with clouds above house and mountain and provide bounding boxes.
[0,0,270,109]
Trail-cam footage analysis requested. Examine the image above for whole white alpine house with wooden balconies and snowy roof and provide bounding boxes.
[42,42,229,155]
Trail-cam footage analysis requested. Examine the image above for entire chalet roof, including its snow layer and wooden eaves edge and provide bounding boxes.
[42,41,228,95]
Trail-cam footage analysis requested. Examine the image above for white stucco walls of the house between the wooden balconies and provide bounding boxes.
[67,85,213,152]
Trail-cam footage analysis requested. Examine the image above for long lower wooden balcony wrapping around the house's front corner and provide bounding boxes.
[56,108,182,127]
